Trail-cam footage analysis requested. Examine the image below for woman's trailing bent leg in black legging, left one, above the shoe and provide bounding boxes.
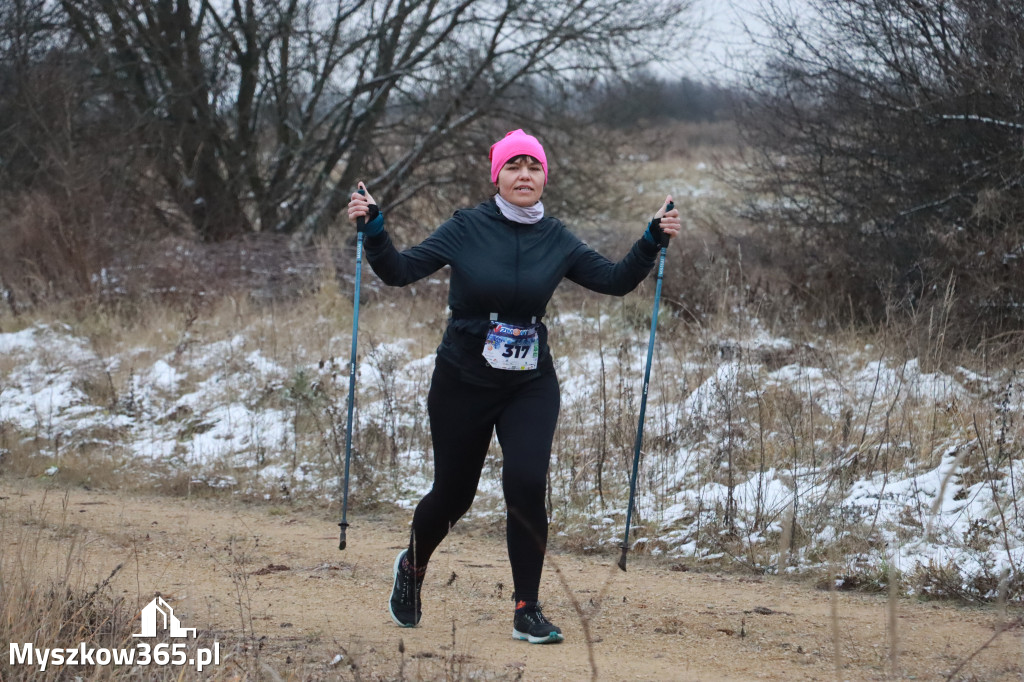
[408,363,499,574]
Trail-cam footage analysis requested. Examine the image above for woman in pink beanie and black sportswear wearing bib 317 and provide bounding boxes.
[348,130,679,643]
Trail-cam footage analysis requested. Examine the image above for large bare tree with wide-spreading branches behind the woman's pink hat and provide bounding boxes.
[60,0,692,241]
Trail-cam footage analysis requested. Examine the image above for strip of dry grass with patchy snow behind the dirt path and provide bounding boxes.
[0,313,1024,598]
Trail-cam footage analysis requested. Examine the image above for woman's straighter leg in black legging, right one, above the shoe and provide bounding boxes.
[497,372,559,601]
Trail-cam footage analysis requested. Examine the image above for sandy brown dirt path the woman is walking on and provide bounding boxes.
[0,480,1024,680]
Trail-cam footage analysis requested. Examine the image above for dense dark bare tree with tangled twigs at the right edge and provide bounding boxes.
[740,0,1024,327]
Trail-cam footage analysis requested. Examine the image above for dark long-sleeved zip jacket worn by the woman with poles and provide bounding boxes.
[366,200,658,384]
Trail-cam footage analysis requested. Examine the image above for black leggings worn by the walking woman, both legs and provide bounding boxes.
[409,360,559,601]
